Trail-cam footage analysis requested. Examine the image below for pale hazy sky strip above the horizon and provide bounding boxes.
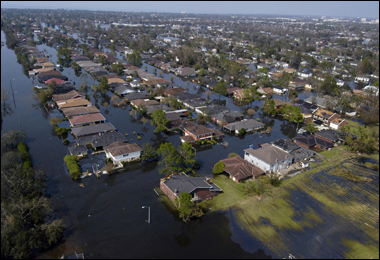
[1,1,379,19]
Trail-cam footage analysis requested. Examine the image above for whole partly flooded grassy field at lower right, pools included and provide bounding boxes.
[202,150,379,258]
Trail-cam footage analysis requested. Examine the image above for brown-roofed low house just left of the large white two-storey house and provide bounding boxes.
[221,155,264,183]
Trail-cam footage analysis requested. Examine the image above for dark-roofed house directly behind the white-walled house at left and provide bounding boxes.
[74,131,127,150]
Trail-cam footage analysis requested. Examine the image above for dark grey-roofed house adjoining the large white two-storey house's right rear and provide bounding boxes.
[271,138,316,163]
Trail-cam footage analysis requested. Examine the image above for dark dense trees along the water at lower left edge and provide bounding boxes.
[1,130,64,259]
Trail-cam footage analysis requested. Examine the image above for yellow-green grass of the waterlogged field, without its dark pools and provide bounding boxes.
[202,150,379,258]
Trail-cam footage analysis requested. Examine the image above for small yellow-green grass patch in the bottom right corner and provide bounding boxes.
[343,240,379,259]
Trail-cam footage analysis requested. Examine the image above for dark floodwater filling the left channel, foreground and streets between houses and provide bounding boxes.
[1,31,372,259]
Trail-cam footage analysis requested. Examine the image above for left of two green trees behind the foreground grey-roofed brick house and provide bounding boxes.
[157,142,182,175]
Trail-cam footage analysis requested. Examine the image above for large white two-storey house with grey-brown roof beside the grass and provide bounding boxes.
[244,143,294,172]
